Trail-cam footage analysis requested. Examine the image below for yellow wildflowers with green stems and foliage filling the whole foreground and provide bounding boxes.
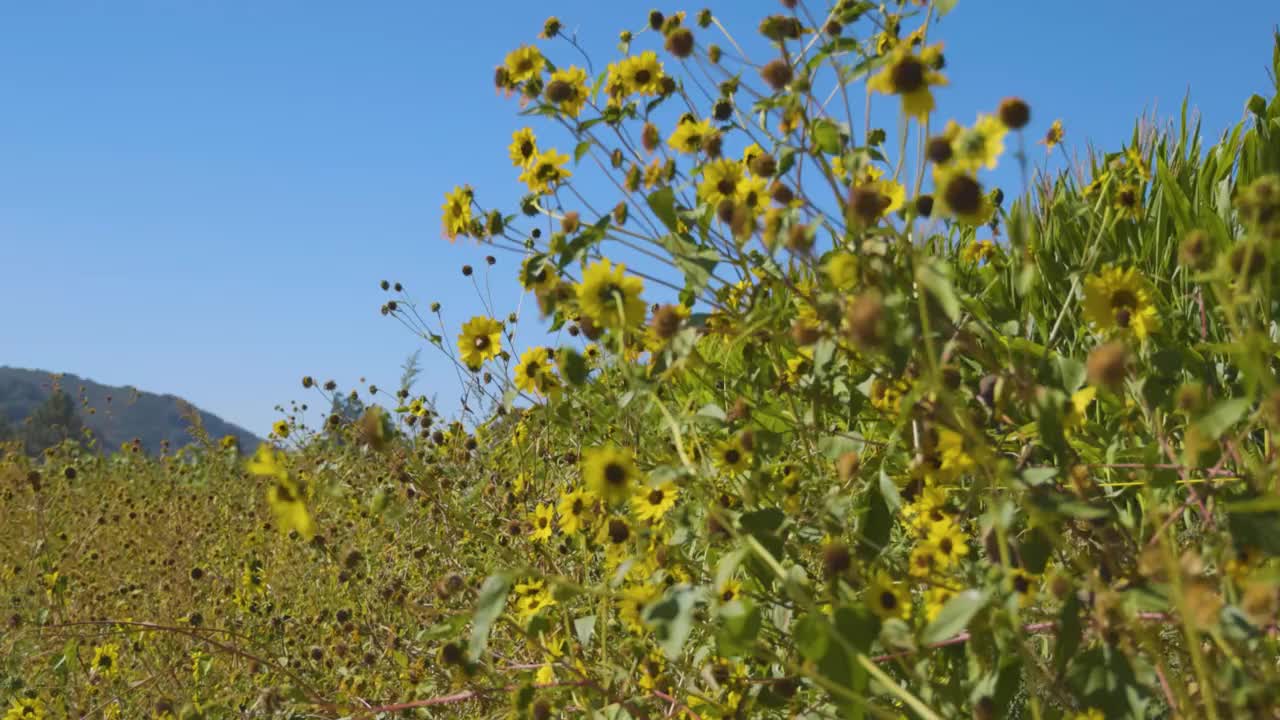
[0,0,1280,720]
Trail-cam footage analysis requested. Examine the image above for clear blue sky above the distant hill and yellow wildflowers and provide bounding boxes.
[0,0,1280,433]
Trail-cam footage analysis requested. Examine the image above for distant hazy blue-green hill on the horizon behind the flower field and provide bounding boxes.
[0,366,262,455]
